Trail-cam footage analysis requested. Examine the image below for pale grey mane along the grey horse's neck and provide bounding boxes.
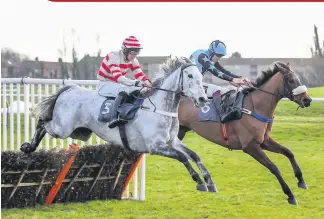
[152,57,192,87]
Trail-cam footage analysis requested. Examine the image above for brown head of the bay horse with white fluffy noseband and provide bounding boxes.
[275,62,312,108]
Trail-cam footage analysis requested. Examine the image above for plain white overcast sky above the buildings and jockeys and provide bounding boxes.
[0,0,324,61]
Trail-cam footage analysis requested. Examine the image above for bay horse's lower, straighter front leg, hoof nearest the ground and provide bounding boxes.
[243,140,297,205]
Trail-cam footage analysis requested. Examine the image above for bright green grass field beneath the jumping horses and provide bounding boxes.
[1,88,324,219]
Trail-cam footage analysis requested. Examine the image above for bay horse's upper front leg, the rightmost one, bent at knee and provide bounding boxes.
[261,138,307,189]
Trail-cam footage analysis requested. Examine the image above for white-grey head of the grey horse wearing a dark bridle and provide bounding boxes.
[180,58,208,107]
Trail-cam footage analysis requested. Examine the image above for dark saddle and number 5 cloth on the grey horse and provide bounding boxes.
[98,91,144,123]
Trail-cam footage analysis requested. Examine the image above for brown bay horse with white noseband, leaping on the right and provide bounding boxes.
[178,62,312,205]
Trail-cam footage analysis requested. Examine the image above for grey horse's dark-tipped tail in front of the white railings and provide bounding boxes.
[32,85,75,121]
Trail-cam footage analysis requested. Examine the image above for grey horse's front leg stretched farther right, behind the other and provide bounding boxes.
[179,143,217,192]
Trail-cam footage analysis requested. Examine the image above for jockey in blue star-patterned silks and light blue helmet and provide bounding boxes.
[190,40,250,97]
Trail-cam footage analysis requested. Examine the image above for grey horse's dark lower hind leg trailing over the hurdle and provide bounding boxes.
[20,120,46,153]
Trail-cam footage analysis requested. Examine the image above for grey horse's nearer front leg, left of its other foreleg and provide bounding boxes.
[150,145,208,191]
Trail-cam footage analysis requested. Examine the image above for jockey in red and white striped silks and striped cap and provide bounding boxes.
[97,36,152,128]
